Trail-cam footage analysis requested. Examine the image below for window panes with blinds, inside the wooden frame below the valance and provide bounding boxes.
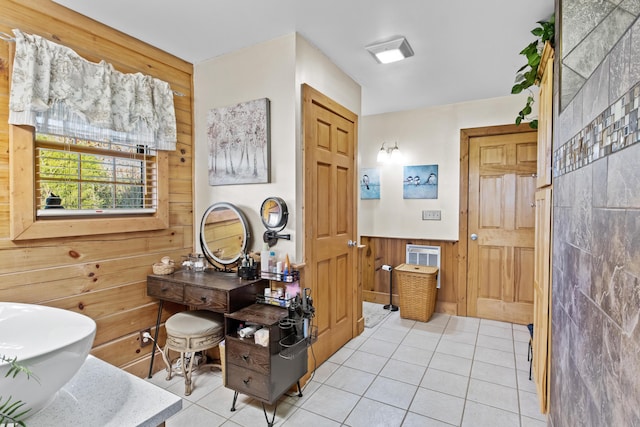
[35,133,157,217]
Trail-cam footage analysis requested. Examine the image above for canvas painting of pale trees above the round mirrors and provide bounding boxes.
[207,98,271,185]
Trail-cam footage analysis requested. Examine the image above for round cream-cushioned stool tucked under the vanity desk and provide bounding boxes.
[164,310,224,396]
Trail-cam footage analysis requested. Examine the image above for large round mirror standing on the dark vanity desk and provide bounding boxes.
[200,202,250,266]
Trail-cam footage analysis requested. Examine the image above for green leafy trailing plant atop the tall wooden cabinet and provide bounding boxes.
[511,15,555,129]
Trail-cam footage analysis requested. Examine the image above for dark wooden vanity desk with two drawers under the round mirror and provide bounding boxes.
[147,270,269,378]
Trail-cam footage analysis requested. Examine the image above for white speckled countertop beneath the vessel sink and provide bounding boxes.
[25,355,182,427]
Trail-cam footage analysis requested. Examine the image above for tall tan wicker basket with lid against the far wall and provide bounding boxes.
[394,264,438,322]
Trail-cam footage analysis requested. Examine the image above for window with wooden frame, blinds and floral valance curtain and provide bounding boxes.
[9,30,177,240]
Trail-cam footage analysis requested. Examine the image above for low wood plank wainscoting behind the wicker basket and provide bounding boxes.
[360,236,466,316]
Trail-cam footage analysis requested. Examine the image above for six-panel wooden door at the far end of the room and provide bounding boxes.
[467,132,537,324]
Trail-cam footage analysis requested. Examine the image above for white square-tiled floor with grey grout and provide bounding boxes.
[149,306,547,427]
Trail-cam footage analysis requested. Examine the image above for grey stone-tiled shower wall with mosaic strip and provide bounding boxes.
[550,6,640,427]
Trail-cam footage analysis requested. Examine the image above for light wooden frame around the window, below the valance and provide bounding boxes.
[9,125,169,240]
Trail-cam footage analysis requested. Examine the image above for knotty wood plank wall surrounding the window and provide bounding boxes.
[0,0,194,376]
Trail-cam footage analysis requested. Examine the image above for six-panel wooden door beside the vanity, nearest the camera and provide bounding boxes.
[303,85,357,364]
